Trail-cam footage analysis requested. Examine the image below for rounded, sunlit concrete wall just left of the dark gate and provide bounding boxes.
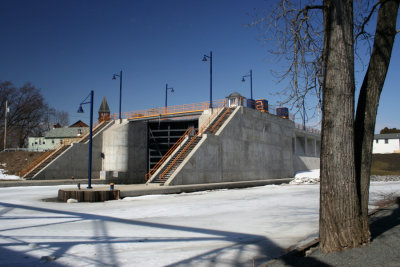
[102,120,147,183]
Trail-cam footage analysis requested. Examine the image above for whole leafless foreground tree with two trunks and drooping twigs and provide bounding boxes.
[254,0,399,252]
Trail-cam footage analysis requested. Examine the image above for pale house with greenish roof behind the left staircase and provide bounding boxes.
[28,124,89,151]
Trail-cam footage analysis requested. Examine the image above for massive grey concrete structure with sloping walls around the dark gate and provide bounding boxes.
[28,99,320,185]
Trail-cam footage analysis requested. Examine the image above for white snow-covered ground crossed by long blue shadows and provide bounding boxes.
[0,178,400,266]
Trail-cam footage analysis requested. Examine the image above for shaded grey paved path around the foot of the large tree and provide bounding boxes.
[261,199,400,267]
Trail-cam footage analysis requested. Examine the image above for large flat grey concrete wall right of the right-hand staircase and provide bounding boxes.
[166,107,294,185]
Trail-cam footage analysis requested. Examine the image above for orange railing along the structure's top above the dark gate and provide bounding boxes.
[112,99,226,120]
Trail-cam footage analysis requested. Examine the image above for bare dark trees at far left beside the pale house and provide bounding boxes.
[0,81,69,148]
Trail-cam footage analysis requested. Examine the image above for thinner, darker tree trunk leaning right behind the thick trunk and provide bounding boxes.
[354,0,400,243]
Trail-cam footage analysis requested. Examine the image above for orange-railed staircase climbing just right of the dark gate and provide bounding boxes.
[151,108,234,184]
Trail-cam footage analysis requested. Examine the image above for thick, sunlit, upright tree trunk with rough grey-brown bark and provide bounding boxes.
[319,0,364,253]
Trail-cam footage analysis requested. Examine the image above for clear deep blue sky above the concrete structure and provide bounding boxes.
[0,0,400,133]
